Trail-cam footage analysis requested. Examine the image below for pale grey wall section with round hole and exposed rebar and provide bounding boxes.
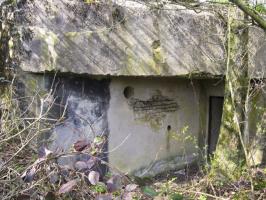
[108,77,223,176]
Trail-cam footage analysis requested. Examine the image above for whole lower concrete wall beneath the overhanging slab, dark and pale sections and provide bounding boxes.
[19,74,224,176]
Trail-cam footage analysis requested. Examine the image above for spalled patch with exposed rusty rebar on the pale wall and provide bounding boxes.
[128,91,179,131]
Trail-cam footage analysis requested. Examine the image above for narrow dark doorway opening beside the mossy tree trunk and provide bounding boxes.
[208,96,224,156]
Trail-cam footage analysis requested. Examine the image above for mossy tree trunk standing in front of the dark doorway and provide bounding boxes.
[212,6,249,180]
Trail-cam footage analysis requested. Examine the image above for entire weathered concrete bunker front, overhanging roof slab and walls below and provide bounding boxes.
[2,0,266,176]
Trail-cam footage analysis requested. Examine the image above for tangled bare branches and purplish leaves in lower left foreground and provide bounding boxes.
[0,81,148,199]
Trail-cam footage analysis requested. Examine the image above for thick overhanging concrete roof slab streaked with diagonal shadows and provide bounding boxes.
[21,0,225,76]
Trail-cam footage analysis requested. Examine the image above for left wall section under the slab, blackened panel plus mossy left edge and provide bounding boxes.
[18,73,110,170]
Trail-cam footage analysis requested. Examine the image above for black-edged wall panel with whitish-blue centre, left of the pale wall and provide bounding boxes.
[46,76,110,151]
